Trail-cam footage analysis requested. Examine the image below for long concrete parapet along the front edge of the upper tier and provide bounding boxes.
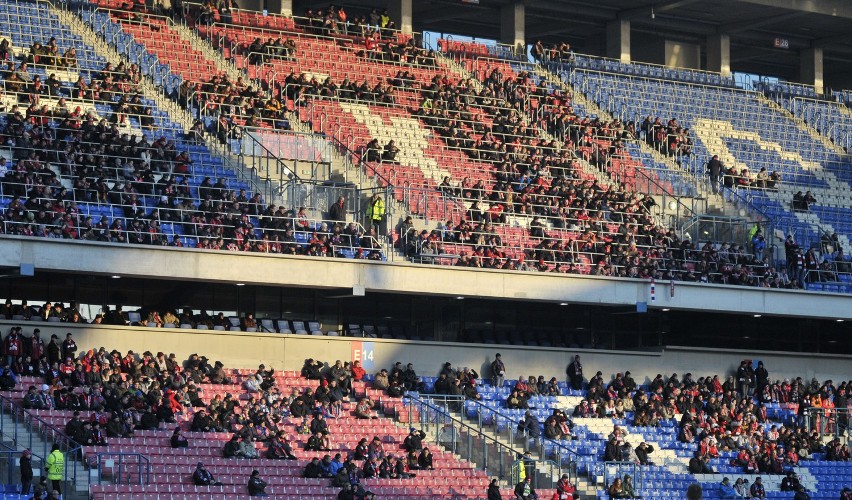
[0,236,852,319]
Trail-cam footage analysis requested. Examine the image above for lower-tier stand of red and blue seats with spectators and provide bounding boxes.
[0,313,850,499]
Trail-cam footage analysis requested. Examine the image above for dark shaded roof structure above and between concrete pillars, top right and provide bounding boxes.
[311,0,852,88]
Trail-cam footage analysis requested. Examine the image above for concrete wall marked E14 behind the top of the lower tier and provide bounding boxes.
[5,321,852,381]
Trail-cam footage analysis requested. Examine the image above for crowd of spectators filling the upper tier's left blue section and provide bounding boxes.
[0,33,381,259]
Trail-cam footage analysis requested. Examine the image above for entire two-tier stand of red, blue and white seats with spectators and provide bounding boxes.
[0,0,852,500]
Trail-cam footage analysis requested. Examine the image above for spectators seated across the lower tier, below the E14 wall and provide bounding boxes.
[0,302,852,498]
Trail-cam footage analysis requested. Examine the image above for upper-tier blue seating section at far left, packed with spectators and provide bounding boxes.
[0,2,383,259]
